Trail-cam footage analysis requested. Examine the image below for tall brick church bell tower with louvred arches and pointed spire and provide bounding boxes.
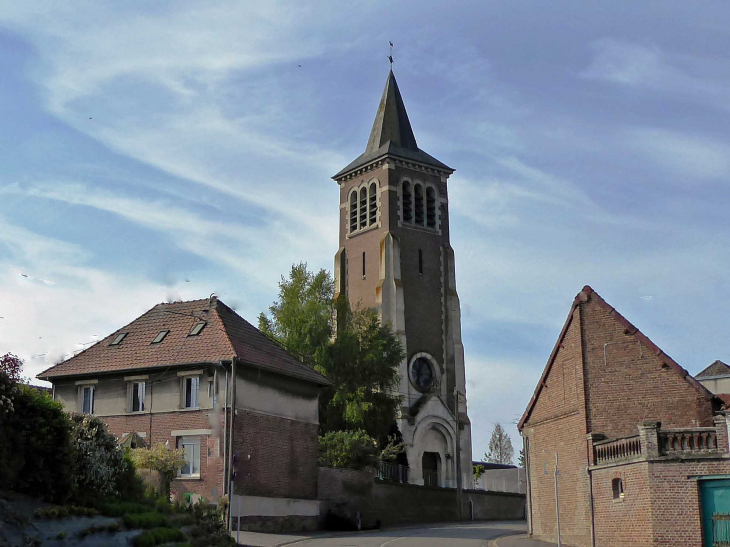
[332,70,472,488]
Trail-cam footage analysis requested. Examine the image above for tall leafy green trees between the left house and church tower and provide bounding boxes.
[259,263,404,448]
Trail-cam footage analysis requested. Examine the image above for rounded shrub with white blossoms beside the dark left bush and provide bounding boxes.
[71,414,127,496]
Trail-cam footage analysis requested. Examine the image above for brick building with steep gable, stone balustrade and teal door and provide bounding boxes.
[518,286,730,547]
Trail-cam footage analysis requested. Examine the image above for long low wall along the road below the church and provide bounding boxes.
[319,467,525,525]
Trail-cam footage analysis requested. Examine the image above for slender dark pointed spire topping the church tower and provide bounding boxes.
[365,69,418,154]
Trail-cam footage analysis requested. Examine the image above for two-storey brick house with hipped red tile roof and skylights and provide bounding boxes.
[38,297,330,528]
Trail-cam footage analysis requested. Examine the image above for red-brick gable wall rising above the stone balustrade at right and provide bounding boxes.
[576,295,713,438]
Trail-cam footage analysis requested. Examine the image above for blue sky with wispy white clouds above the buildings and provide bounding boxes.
[0,0,730,459]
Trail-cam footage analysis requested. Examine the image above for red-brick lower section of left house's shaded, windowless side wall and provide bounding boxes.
[233,409,318,499]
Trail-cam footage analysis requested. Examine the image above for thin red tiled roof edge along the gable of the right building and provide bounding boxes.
[517,285,717,431]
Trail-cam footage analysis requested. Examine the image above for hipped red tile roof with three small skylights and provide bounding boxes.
[38,297,330,385]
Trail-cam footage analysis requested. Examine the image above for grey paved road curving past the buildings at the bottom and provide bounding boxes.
[278,521,525,547]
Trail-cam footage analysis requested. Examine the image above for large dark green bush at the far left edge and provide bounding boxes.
[0,373,75,502]
